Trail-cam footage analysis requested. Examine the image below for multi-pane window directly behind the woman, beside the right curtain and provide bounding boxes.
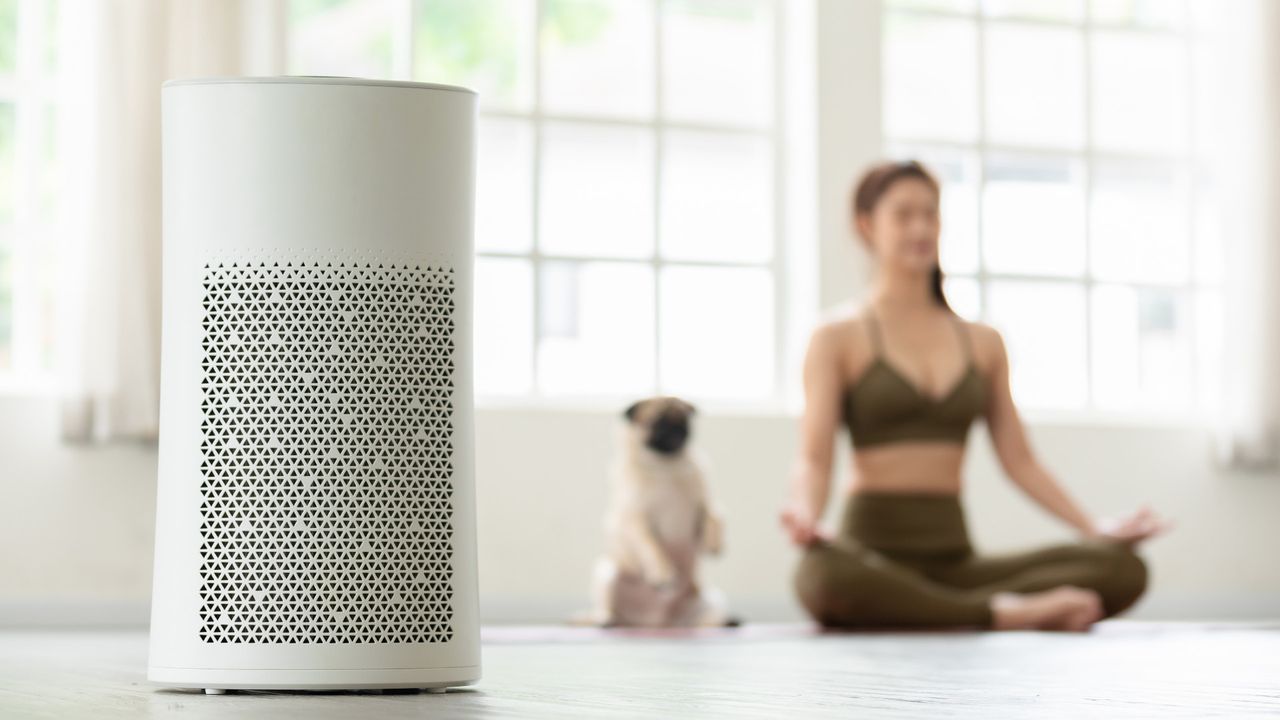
[883,0,1221,416]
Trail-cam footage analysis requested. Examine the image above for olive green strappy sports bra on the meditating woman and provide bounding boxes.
[844,310,987,447]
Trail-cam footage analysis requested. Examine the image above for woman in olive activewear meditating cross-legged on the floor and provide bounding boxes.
[782,161,1170,630]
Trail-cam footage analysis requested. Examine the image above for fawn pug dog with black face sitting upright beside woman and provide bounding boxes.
[591,396,740,628]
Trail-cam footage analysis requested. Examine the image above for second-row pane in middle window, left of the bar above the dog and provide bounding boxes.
[539,123,654,258]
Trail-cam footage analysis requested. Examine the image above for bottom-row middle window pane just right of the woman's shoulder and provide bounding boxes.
[987,281,1088,409]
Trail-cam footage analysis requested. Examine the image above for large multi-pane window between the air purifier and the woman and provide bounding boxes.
[289,0,786,402]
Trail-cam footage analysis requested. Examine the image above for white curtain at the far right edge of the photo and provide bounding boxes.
[1202,0,1280,473]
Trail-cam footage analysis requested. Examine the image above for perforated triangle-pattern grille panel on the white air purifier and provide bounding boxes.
[200,263,456,643]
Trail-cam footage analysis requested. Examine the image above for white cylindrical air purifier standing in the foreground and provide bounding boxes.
[147,77,480,692]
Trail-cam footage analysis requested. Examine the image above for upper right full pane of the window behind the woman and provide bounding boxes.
[1092,31,1190,152]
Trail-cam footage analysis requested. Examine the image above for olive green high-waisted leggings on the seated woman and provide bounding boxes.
[792,491,1147,628]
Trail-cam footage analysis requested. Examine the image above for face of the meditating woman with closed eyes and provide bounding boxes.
[858,178,942,270]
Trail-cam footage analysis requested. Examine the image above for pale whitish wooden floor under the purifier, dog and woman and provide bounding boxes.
[0,620,1280,720]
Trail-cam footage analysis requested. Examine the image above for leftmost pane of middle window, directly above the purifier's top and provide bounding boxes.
[289,0,396,78]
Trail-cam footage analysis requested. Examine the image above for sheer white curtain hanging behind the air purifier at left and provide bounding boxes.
[58,0,283,441]
